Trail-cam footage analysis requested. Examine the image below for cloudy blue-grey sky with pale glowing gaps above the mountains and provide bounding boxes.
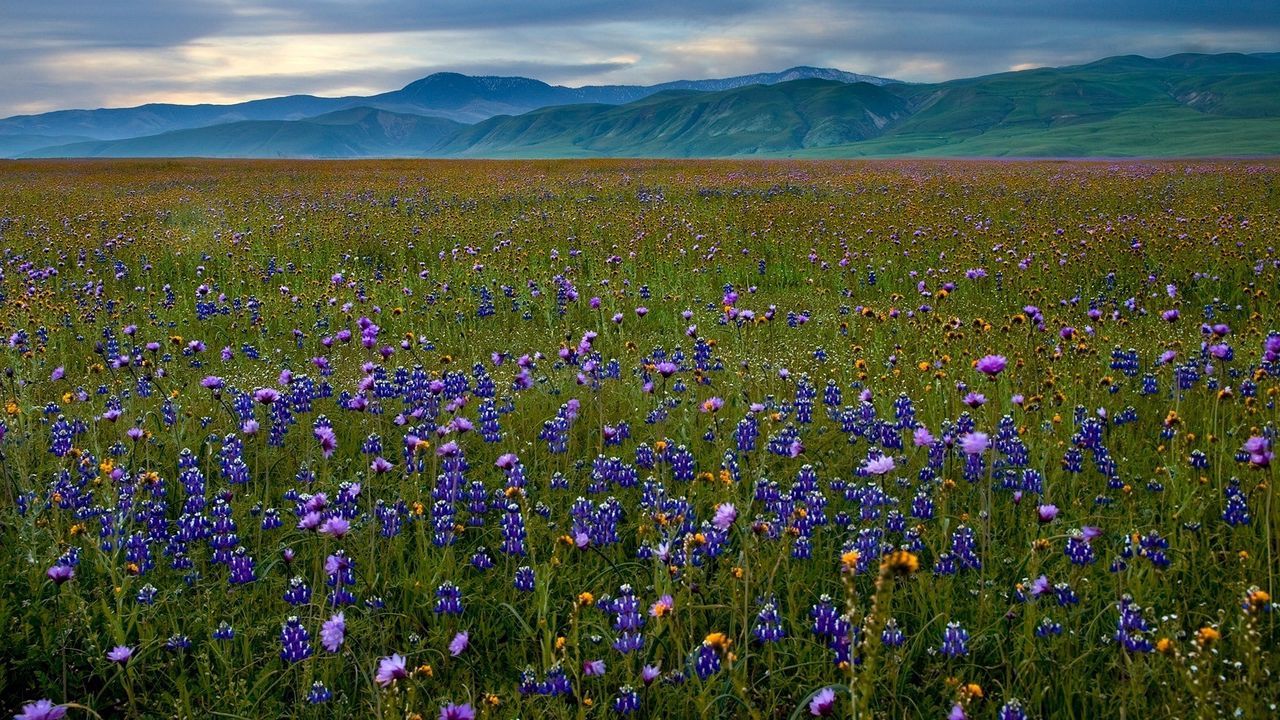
[0,0,1280,117]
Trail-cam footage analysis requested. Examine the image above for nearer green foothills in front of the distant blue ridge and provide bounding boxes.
[17,54,1280,158]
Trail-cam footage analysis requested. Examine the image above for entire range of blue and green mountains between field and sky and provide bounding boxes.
[0,53,1280,158]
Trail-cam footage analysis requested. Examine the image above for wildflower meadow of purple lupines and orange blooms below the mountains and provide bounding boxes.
[0,161,1280,720]
